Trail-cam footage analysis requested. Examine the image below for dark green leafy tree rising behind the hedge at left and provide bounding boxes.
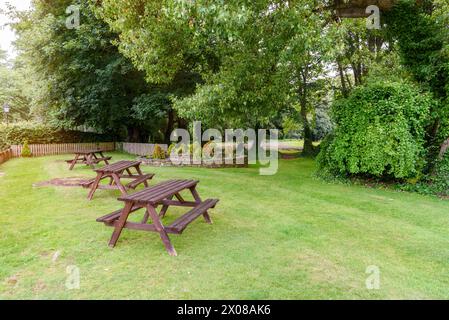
[14,0,171,142]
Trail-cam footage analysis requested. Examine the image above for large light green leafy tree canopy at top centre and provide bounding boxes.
[98,0,332,151]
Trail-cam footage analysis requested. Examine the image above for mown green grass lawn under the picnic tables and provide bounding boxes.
[0,153,449,299]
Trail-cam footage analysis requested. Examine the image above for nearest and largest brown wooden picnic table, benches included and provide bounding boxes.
[97,180,219,256]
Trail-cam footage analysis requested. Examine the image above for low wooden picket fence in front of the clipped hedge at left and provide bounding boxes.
[11,142,115,157]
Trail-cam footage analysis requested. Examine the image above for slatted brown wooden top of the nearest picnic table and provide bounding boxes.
[118,180,199,205]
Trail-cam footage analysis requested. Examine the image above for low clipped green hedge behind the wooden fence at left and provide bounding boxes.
[0,122,114,147]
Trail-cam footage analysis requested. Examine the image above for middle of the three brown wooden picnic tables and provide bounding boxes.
[83,160,154,200]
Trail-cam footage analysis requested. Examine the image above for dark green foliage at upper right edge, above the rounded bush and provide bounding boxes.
[385,0,449,152]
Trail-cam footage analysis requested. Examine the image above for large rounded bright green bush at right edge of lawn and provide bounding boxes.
[318,82,435,179]
